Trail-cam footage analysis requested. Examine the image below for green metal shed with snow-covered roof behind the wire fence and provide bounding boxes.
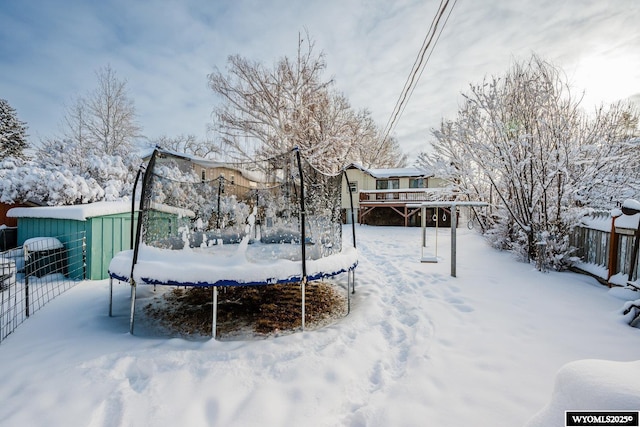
[7,202,137,280]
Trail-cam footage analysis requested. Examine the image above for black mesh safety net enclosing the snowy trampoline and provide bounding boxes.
[134,149,342,262]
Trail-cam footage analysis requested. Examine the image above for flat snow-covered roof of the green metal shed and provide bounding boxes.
[7,202,131,221]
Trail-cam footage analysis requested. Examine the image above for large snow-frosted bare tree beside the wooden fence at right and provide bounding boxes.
[420,55,638,266]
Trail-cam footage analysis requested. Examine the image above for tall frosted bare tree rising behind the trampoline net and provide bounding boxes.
[209,34,402,172]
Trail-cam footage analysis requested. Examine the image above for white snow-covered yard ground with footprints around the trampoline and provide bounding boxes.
[0,226,640,427]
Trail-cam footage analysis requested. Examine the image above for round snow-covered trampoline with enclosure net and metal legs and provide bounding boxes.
[109,148,358,338]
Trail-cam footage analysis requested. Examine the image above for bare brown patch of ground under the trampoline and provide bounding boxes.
[144,282,347,340]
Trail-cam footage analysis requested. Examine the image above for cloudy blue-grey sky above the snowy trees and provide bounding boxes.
[0,0,640,158]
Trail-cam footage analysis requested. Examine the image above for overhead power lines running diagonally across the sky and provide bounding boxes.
[378,0,457,156]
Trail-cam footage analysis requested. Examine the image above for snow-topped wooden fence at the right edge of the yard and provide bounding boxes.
[571,213,639,285]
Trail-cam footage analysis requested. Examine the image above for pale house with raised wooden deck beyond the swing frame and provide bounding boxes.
[342,163,451,227]
